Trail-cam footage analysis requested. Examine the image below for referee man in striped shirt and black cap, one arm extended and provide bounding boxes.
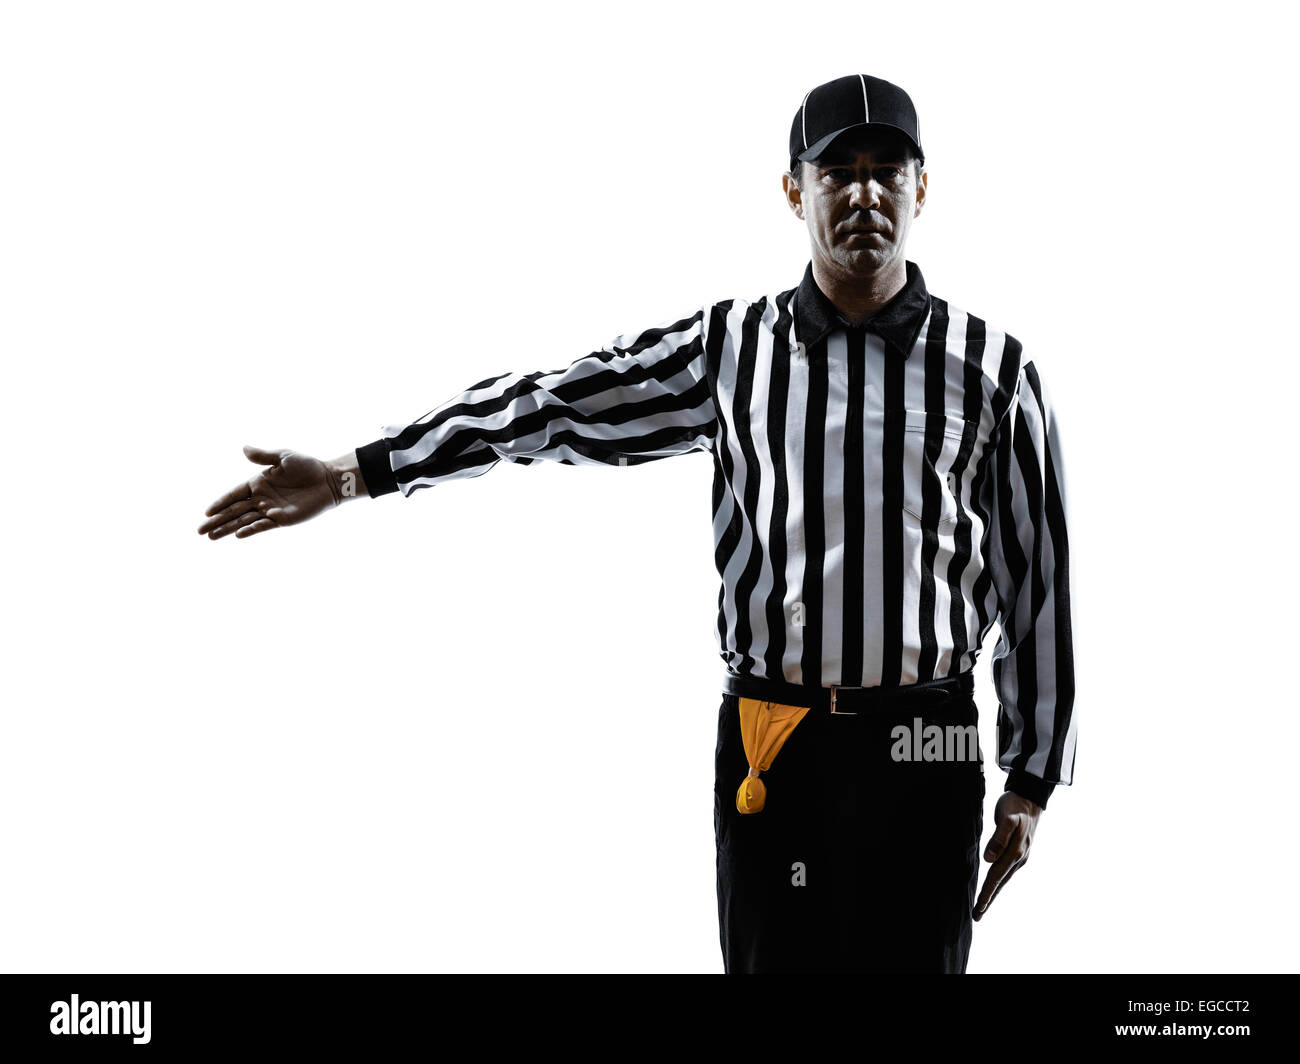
[199,74,1076,972]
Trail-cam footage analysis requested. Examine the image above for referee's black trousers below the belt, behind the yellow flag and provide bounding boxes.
[714,692,984,973]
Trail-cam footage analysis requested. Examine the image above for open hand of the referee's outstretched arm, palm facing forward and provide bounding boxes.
[199,446,365,540]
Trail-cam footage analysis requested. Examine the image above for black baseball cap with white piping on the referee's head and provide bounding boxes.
[790,74,926,163]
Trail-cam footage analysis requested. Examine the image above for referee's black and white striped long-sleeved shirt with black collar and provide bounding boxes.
[358,261,1076,805]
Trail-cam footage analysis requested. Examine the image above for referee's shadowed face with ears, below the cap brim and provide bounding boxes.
[785,130,928,277]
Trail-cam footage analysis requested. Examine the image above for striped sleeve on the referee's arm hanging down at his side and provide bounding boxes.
[989,360,1076,808]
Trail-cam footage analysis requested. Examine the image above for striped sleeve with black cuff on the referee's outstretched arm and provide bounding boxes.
[358,307,718,496]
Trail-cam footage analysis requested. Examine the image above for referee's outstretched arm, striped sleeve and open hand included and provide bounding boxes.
[199,306,718,540]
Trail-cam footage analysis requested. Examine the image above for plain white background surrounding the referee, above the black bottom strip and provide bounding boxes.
[0,0,1300,973]
